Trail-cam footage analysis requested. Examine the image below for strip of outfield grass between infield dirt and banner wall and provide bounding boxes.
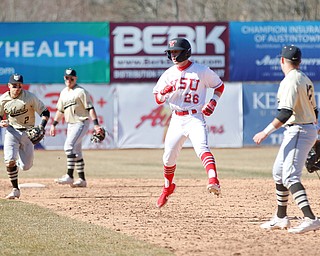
[13,147,278,179]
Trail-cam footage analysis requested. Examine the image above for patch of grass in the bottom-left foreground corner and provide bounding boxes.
[0,200,172,256]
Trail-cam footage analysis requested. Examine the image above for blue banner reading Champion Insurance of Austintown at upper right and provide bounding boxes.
[230,21,320,81]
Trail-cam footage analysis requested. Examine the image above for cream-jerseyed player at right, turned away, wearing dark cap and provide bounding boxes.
[253,45,320,233]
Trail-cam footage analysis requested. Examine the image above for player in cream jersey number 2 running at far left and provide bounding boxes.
[0,74,50,199]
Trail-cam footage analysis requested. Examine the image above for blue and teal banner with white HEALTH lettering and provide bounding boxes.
[0,22,110,83]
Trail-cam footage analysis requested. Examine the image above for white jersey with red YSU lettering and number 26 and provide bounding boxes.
[153,62,223,113]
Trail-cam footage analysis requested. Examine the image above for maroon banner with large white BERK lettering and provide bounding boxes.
[110,22,229,82]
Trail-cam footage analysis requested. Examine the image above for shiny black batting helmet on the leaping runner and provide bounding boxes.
[166,37,191,62]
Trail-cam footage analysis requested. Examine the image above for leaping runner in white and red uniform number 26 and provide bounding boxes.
[153,37,224,208]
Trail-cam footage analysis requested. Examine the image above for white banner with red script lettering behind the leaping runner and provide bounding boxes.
[117,83,243,148]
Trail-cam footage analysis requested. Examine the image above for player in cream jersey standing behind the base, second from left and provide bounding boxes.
[50,68,101,187]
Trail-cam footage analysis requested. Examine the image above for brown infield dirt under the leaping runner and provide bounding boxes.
[0,179,320,256]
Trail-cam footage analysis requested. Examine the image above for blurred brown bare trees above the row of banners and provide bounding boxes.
[0,0,320,22]
